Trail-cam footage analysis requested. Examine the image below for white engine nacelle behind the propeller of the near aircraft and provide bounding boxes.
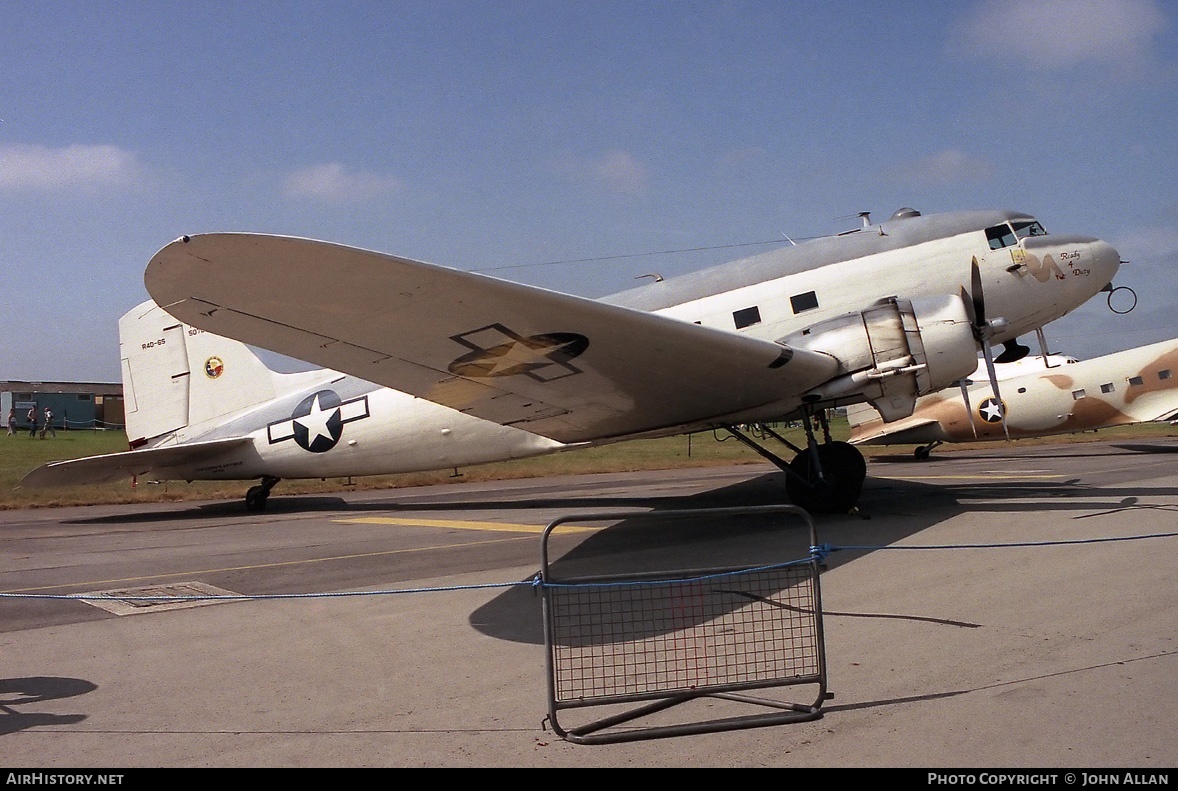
[780,295,978,421]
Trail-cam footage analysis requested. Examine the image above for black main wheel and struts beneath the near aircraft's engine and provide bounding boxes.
[724,409,867,514]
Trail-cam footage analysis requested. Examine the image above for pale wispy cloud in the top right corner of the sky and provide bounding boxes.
[949,0,1167,71]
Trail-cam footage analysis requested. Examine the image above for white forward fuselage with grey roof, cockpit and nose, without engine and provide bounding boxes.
[605,211,1120,358]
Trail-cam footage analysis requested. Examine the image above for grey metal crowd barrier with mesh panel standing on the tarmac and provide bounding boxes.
[541,506,828,744]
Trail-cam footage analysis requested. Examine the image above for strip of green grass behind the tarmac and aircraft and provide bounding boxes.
[0,420,1176,509]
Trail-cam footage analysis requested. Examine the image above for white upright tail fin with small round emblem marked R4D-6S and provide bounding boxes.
[119,299,294,447]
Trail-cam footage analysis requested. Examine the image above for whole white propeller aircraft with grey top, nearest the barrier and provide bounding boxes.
[24,209,1120,512]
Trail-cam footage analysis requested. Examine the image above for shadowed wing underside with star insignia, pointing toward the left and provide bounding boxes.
[144,233,838,443]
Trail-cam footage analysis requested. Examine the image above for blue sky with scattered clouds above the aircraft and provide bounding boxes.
[0,0,1178,381]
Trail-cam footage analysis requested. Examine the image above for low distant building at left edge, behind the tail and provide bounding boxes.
[0,382,126,431]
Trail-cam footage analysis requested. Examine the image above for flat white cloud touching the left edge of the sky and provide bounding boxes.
[0,143,146,190]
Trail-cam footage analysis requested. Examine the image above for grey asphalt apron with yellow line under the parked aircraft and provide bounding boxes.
[0,440,1178,769]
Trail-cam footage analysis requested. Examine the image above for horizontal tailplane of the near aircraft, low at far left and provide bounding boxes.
[20,437,251,489]
